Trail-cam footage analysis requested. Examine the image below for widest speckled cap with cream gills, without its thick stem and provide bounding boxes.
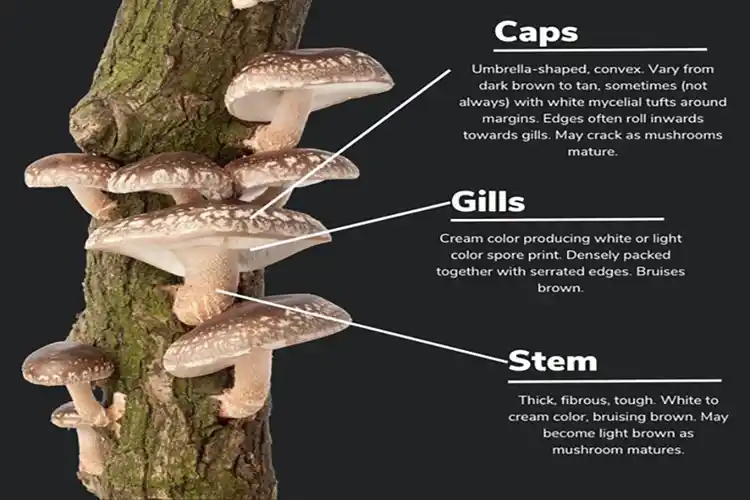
[85,201,331,276]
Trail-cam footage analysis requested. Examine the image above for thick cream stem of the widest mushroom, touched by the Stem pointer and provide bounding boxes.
[172,247,240,326]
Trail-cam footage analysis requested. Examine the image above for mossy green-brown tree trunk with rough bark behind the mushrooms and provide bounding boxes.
[65,0,311,500]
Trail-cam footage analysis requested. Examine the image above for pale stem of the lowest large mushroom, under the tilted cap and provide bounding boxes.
[211,349,273,418]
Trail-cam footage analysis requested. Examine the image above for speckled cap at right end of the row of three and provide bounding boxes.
[224,148,359,194]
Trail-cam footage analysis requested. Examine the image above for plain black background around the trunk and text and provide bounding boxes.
[0,0,747,500]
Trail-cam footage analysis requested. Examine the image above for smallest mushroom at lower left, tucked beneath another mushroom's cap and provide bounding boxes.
[50,401,105,476]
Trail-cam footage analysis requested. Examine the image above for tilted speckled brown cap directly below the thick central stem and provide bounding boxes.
[163,294,351,377]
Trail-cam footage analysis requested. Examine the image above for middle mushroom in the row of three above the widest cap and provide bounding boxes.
[108,151,232,204]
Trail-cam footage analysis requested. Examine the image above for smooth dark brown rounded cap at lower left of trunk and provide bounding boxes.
[21,340,115,386]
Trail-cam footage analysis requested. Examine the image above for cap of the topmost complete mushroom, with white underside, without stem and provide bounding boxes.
[224,48,394,122]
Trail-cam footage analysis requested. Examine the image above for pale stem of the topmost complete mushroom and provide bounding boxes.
[246,89,314,153]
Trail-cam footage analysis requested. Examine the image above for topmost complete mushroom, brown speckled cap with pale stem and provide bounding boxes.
[224,48,394,152]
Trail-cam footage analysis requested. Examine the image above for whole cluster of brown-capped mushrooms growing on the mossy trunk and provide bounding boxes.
[22,46,393,475]
